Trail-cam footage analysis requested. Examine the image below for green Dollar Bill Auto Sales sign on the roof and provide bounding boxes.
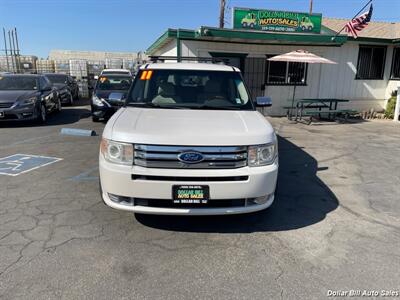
[233,7,322,33]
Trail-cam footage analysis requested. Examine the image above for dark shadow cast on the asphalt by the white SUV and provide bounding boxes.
[135,137,339,233]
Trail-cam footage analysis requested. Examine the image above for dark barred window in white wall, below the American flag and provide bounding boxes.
[356,45,386,79]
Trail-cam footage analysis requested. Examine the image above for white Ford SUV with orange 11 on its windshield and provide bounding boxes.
[99,63,278,215]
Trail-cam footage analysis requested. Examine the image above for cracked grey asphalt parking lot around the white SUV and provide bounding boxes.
[0,104,400,299]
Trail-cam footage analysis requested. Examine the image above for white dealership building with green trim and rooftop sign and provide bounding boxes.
[146,8,400,115]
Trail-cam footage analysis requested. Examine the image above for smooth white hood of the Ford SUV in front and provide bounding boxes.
[104,107,275,146]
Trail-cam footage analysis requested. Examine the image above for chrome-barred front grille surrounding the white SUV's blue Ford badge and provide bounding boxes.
[135,144,247,169]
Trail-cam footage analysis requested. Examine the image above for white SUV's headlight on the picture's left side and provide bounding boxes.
[100,138,133,165]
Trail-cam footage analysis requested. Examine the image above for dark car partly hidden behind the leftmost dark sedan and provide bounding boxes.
[43,73,79,105]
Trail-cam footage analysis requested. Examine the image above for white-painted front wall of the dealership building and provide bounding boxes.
[157,41,397,115]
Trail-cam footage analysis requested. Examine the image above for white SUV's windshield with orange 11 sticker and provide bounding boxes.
[127,69,254,110]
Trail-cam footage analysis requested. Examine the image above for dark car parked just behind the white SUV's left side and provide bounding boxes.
[91,75,132,122]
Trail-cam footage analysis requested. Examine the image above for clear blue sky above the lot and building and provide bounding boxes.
[0,0,400,58]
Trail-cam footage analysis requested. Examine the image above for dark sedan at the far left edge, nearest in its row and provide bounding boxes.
[0,75,61,123]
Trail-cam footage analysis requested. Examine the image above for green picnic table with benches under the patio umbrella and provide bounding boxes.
[285,98,356,123]
